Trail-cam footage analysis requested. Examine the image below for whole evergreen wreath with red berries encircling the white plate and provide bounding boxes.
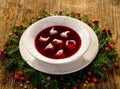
[0,10,119,89]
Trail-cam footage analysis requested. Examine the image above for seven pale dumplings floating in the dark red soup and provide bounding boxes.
[39,27,76,57]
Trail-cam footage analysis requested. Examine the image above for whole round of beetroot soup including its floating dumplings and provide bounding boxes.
[35,26,81,59]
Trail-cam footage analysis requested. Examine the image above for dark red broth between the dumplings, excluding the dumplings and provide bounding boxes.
[35,26,81,59]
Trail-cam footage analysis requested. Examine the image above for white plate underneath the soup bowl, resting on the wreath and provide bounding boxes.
[19,22,99,75]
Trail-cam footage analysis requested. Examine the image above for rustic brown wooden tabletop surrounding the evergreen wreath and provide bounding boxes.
[0,0,120,89]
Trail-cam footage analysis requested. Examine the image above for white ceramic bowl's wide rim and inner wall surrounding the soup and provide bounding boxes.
[25,16,90,65]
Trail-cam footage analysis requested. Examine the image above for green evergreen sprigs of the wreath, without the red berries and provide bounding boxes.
[3,10,117,89]
